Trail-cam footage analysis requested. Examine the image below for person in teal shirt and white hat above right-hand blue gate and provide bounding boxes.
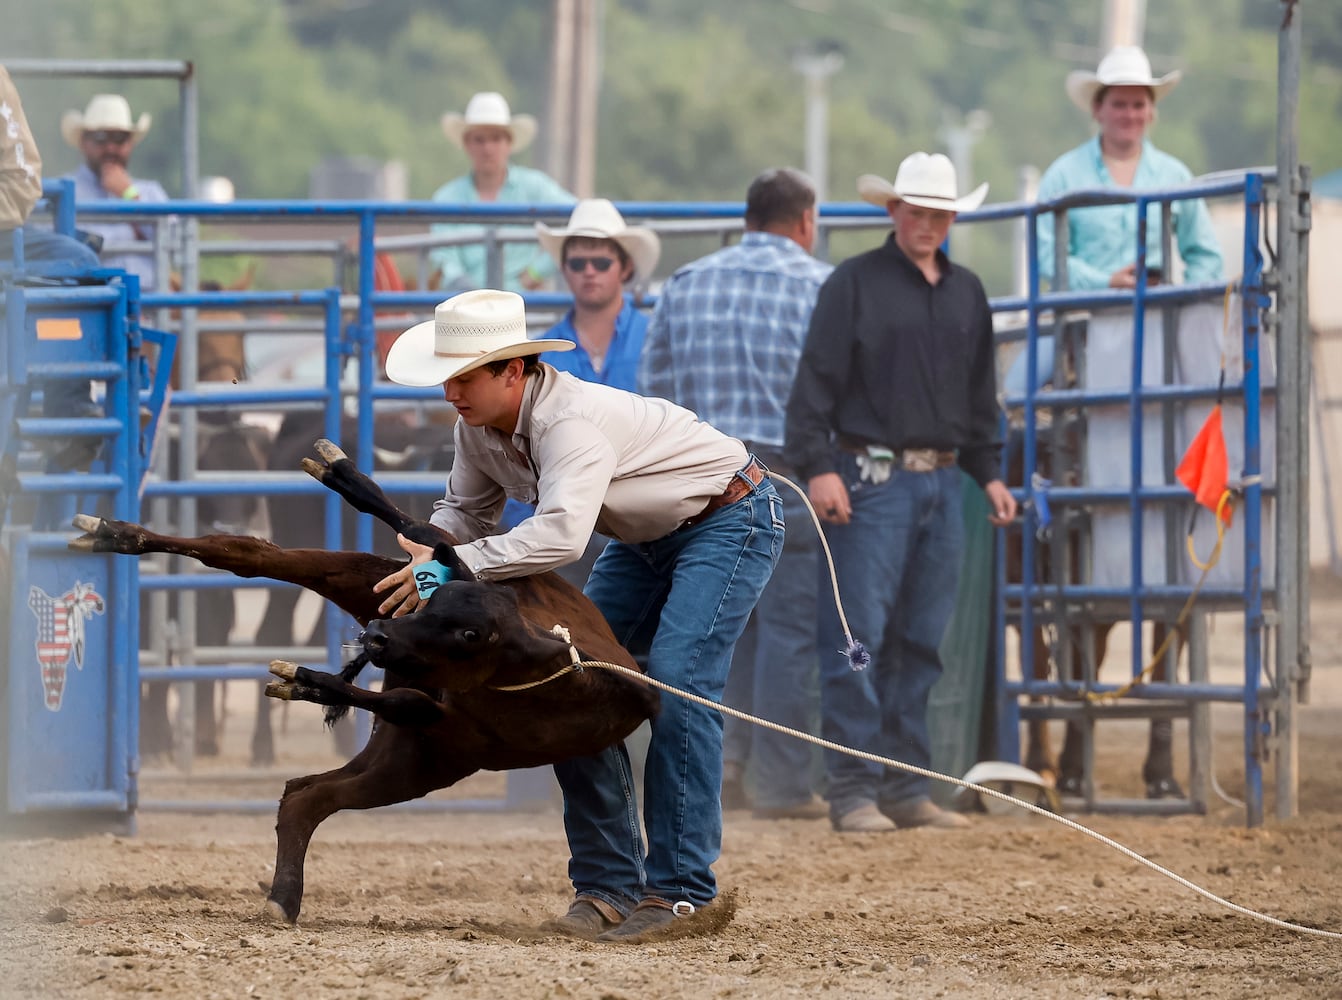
[1039,46,1223,289]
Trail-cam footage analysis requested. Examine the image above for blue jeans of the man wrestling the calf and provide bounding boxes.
[554,479,784,914]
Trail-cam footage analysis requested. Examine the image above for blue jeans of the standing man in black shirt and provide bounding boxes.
[820,454,964,820]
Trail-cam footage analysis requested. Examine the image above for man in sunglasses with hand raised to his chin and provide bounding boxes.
[60,94,168,291]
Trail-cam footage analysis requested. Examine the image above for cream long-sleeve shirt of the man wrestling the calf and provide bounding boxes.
[431,364,746,580]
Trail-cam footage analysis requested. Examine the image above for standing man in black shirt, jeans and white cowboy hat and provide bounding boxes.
[785,153,1016,832]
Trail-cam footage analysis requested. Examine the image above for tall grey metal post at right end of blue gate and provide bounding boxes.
[1275,0,1310,819]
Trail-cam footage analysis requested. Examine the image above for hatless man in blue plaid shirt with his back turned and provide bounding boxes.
[639,169,833,819]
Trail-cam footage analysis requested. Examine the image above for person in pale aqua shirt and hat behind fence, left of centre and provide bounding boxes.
[429,91,574,291]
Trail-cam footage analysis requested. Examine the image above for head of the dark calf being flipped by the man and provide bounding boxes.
[362,581,569,691]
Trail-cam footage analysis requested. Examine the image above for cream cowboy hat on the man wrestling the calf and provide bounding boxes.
[386,289,577,387]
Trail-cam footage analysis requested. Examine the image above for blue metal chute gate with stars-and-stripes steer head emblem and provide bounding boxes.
[0,272,146,828]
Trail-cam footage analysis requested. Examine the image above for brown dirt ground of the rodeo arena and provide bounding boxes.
[0,580,1342,1000]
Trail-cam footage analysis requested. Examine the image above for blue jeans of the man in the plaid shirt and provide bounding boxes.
[722,486,829,809]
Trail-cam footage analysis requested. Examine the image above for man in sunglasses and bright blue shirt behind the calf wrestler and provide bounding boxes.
[535,197,662,392]
